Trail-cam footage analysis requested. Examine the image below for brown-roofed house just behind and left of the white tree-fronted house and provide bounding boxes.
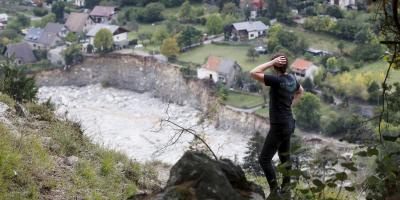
[65,13,91,33]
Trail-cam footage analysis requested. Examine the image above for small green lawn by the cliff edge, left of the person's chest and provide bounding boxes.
[225,91,264,108]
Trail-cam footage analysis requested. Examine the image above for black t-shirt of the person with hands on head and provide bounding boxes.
[264,74,300,123]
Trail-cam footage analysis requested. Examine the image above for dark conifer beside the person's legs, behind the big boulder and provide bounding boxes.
[243,131,265,176]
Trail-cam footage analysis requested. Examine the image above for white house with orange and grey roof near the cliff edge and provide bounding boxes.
[197,56,241,87]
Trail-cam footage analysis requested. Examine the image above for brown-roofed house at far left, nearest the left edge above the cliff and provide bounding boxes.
[4,42,37,65]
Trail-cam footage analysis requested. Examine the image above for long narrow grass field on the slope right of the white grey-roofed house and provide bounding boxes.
[283,25,355,52]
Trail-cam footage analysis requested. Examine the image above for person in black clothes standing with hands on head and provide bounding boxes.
[250,54,303,199]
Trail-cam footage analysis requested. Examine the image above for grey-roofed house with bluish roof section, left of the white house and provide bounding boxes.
[24,23,68,49]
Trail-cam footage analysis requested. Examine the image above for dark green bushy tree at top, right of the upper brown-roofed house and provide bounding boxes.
[137,3,165,23]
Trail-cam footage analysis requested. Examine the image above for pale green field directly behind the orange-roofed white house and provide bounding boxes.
[178,44,269,71]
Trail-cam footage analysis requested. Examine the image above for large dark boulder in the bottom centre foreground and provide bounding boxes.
[129,151,265,200]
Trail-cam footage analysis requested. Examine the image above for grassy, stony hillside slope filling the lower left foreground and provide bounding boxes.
[0,94,163,200]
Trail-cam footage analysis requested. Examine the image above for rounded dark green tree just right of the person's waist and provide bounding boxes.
[293,92,321,130]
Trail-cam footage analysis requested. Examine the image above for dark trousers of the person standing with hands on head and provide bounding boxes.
[259,119,295,190]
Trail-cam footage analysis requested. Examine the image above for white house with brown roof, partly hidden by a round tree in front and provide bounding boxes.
[86,24,129,49]
